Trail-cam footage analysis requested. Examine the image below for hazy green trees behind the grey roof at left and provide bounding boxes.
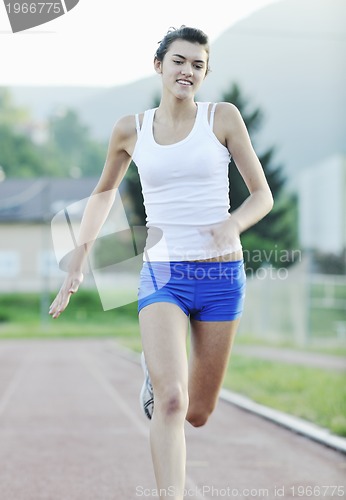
[0,88,107,177]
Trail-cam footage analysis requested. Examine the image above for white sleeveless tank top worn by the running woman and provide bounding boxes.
[132,102,241,261]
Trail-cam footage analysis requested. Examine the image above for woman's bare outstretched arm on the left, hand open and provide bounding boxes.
[49,116,136,319]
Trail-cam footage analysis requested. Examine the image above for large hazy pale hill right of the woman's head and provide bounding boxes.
[203,0,346,180]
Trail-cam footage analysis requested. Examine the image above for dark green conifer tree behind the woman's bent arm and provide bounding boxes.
[222,83,297,270]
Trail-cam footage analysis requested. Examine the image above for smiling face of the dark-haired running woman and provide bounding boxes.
[154,40,208,99]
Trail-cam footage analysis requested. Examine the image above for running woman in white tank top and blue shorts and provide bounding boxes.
[50,26,273,500]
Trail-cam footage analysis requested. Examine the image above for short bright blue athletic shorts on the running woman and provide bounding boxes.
[138,260,246,321]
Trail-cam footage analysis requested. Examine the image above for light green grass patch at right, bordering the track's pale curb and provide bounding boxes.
[224,355,346,436]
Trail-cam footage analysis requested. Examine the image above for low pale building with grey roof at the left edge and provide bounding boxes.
[0,177,97,293]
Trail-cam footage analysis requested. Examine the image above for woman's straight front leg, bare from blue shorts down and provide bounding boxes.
[139,302,188,500]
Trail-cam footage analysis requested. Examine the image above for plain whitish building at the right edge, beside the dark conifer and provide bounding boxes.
[297,155,346,254]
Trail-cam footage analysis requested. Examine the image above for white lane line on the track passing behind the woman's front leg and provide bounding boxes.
[80,351,208,500]
